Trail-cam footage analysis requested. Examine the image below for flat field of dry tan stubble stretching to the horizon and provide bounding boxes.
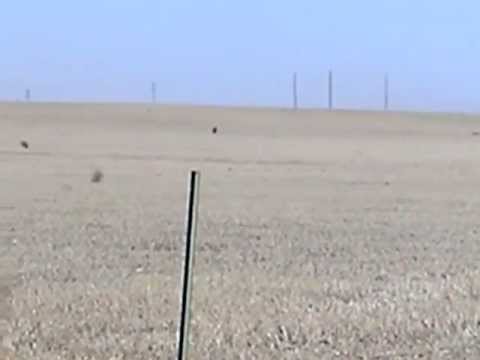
[0,104,480,360]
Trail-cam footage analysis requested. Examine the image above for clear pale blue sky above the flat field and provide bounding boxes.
[0,0,480,112]
